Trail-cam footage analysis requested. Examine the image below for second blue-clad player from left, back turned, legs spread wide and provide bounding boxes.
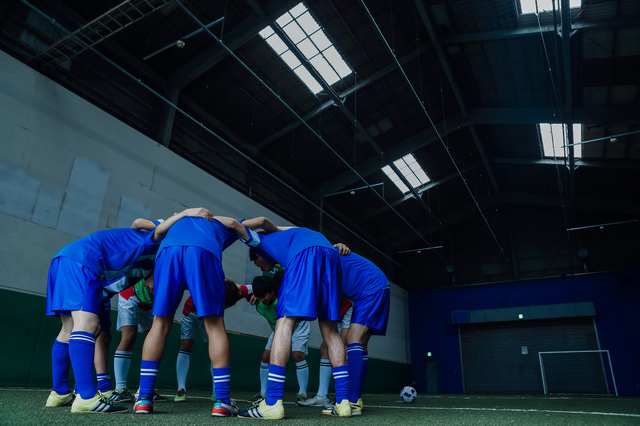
[134,216,248,417]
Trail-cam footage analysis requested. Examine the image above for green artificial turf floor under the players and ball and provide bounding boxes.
[0,388,640,426]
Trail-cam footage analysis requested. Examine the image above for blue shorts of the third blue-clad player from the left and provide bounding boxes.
[278,247,342,321]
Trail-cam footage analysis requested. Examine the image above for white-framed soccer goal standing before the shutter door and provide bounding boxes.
[538,350,618,396]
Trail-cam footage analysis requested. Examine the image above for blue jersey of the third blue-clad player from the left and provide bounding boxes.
[256,228,335,268]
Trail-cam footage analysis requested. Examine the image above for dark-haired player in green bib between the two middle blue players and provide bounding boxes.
[249,270,310,406]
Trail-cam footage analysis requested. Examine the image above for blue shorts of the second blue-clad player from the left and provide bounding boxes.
[152,246,225,317]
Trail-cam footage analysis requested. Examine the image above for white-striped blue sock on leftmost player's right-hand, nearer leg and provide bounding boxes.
[69,331,97,399]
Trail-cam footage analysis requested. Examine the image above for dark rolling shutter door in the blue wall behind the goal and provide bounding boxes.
[460,317,607,393]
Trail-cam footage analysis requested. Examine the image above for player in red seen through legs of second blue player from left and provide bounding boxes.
[173,278,252,402]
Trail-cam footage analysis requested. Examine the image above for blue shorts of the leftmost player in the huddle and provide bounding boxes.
[46,256,102,315]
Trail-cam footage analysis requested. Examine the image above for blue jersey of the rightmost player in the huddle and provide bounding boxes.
[340,252,389,301]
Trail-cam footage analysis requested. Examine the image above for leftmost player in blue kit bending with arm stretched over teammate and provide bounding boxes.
[46,208,211,413]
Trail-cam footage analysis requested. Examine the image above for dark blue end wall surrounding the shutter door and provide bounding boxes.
[409,270,640,395]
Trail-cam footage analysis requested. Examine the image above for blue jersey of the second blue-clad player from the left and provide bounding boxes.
[158,217,237,262]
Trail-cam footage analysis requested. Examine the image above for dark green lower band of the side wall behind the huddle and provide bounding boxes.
[0,289,411,395]
